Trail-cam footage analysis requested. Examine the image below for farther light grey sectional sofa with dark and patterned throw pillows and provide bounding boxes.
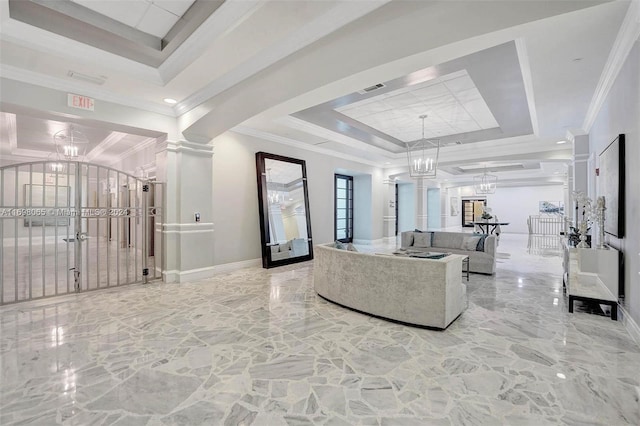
[401,231,497,274]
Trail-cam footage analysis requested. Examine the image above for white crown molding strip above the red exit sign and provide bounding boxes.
[0,64,176,117]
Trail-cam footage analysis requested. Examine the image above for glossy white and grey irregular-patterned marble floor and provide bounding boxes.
[0,234,640,426]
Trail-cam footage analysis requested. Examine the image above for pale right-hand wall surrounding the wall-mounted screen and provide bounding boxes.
[589,41,640,330]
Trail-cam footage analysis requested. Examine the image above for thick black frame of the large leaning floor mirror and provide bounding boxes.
[256,152,313,268]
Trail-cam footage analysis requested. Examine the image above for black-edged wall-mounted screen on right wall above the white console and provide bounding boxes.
[598,134,625,238]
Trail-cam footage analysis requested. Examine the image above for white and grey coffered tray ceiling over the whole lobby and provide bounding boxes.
[0,0,629,186]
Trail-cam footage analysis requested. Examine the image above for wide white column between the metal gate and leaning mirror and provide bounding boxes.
[156,140,214,282]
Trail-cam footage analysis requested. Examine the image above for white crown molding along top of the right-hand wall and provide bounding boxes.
[582,0,640,133]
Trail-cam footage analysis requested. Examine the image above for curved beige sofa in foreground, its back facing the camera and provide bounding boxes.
[313,244,467,329]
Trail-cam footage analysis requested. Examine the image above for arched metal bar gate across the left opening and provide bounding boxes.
[0,161,164,305]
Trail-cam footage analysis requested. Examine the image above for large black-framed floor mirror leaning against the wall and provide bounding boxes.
[256,152,313,268]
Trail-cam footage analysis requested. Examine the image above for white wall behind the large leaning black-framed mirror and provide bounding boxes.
[213,131,384,265]
